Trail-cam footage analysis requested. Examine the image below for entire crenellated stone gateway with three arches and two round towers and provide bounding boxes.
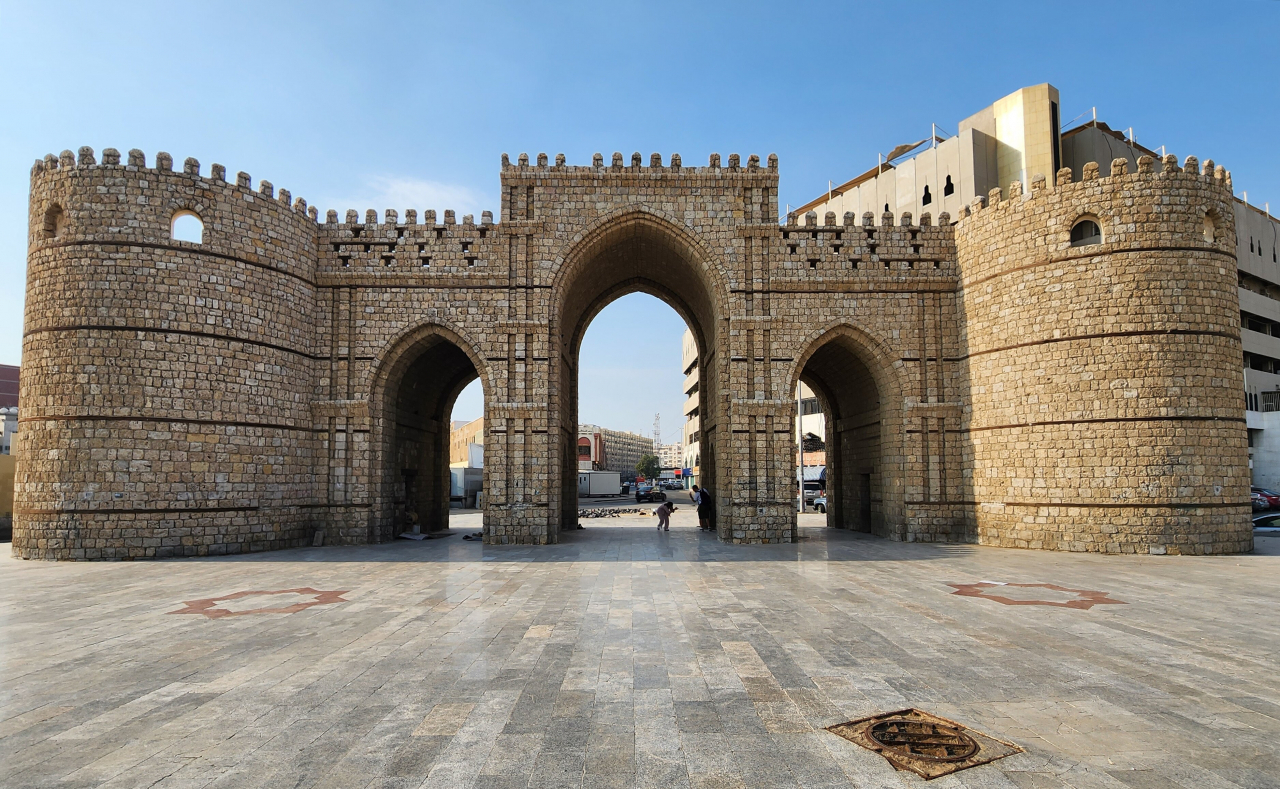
[13,147,1252,560]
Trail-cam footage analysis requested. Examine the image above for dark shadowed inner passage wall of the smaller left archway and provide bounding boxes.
[380,337,479,539]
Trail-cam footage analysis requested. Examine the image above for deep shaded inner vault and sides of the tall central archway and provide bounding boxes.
[549,209,728,541]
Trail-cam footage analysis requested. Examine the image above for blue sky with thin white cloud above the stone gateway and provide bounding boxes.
[0,0,1280,432]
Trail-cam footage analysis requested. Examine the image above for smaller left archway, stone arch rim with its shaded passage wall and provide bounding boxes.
[369,323,493,542]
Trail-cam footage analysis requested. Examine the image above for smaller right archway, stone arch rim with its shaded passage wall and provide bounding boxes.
[790,323,906,539]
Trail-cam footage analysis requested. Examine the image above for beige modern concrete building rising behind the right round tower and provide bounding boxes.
[791,85,1280,488]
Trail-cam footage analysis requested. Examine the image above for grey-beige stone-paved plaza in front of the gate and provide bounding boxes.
[0,507,1280,789]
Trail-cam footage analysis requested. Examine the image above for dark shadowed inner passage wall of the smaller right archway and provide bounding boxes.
[800,338,886,534]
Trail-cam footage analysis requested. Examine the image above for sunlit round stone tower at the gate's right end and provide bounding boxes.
[956,156,1252,553]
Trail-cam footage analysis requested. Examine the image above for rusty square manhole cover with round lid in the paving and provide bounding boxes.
[827,708,1023,780]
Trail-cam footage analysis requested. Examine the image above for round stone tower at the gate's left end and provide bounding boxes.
[13,147,316,558]
